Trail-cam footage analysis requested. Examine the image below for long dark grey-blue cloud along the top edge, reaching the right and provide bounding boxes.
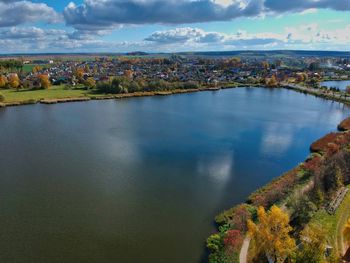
[64,0,350,31]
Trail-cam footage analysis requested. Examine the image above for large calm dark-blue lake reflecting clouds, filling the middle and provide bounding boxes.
[0,88,350,263]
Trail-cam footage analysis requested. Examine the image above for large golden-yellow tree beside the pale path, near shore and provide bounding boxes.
[248,205,295,263]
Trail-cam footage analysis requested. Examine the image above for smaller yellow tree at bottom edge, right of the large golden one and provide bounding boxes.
[296,224,327,263]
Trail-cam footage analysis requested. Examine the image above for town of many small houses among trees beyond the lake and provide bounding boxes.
[6,55,350,87]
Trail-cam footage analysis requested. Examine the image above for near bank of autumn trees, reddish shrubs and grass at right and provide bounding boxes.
[207,119,350,263]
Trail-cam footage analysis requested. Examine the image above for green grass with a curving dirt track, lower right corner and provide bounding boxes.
[311,186,350,254]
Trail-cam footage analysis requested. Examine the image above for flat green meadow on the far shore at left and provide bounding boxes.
[0,85,88,102]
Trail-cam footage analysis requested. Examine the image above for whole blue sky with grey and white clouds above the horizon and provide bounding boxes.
[0,0,350,54]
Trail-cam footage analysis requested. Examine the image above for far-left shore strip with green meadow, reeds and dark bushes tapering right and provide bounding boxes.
[0,72,237,106]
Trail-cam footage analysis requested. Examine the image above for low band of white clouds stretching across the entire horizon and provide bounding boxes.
[0,23,350,53]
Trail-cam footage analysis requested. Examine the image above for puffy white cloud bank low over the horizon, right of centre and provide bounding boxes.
[145,23,350,49]
